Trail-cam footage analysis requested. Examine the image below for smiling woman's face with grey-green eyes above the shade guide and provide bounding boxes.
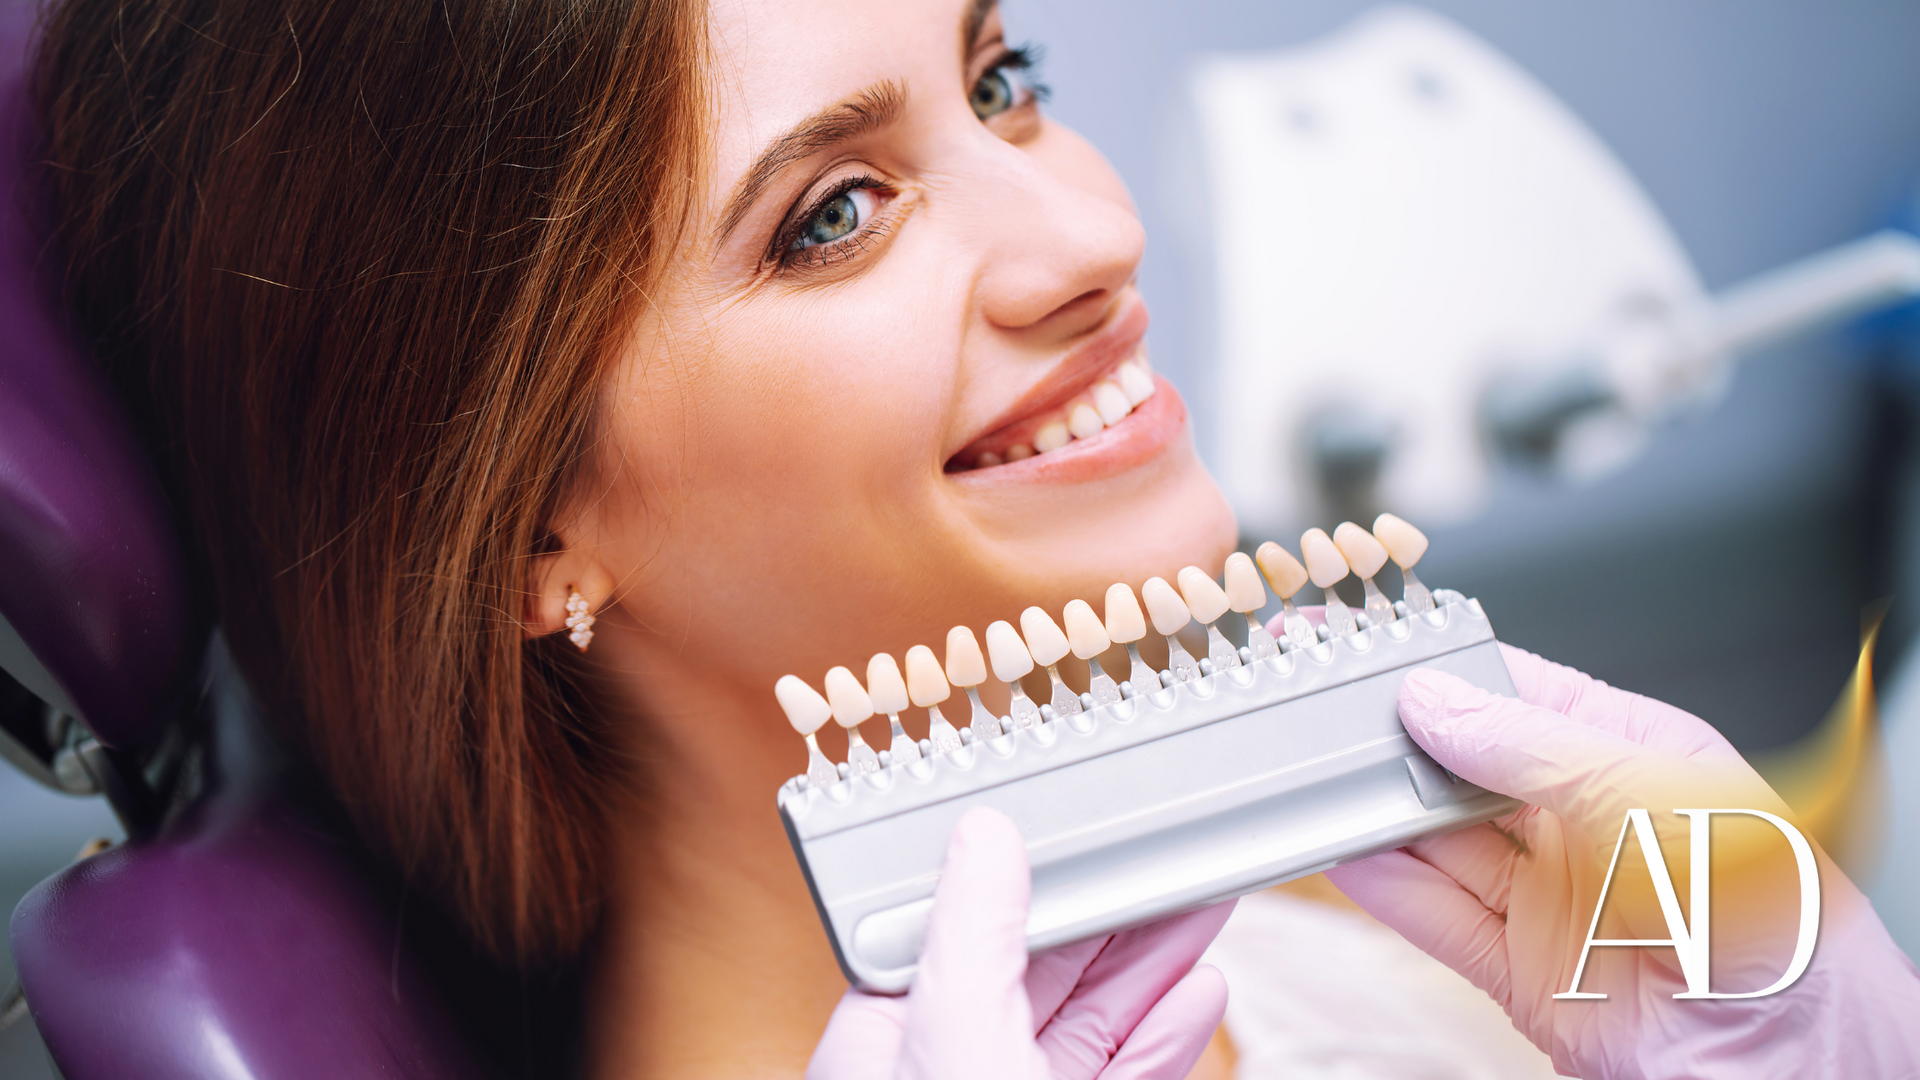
[574,0,1235,709]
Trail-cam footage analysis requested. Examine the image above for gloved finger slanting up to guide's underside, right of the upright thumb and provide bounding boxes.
[1037,901,1233,1078]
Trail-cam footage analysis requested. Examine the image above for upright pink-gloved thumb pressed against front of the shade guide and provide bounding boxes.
[899,807,1044,1076]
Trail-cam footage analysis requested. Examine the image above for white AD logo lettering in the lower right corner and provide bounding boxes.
[1553,809,1820,1001]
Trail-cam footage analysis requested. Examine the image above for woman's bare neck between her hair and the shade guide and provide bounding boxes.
[588,642,847,1080]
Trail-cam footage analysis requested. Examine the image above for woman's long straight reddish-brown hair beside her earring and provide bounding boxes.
[36,0,705,965]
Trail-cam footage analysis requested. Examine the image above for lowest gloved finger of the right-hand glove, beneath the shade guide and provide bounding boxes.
[1327,849,1513,1007]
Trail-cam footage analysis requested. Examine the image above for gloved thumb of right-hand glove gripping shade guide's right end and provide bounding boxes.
[1400,667,1772,834]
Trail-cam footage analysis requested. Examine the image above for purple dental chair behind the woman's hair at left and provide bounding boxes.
[0,0,520,1080]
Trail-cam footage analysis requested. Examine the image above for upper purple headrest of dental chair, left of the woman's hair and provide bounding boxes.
[0,0,205,748]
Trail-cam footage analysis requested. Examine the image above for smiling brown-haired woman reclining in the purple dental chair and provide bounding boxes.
[38,0,1920,1076]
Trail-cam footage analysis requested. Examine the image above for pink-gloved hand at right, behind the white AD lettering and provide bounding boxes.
[1327,646,1920,1080]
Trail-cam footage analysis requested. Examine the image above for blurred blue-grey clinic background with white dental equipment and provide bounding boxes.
[0,0,1920,1080]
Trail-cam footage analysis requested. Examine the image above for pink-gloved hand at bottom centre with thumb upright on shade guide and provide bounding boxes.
[806,807,1233,1080]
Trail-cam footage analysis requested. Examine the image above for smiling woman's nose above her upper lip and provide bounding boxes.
[977,133,1146,336]
